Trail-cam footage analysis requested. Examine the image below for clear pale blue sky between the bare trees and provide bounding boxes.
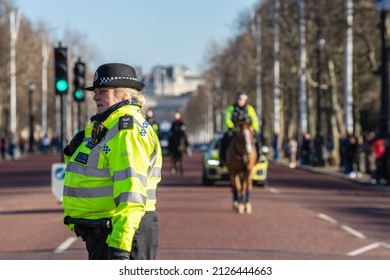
[13,0,261,73]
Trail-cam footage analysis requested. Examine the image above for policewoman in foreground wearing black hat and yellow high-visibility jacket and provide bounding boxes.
[63,63,162,260]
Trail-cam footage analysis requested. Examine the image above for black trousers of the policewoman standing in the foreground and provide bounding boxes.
[75,211,159,260]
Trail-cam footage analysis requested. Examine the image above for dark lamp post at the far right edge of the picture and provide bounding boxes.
[376,0,390,137]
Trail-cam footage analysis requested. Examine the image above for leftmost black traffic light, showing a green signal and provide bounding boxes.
[54,46,69,95]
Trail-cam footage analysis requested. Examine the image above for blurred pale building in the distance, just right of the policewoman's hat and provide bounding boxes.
[142,65,204,96]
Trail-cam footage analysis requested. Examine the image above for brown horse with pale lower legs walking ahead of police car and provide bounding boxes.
[225,122,257,214]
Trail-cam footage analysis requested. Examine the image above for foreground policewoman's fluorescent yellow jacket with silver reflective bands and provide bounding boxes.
[63,105,162,251]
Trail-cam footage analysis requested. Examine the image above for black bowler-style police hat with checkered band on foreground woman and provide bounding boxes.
[85,63,145,91]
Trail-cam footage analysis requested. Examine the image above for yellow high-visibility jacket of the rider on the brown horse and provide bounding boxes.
[224,104,260,133]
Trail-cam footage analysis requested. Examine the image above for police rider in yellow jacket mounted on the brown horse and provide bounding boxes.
[219,91,259,166]
